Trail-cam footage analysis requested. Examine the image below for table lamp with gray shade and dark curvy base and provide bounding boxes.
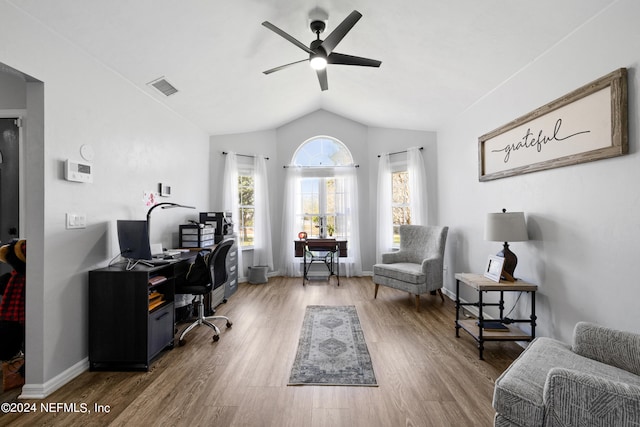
[484,209,529,282]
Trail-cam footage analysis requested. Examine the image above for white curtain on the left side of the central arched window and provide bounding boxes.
[279,167,302,277]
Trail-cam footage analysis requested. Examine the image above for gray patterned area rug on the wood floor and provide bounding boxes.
[289,305,378,386]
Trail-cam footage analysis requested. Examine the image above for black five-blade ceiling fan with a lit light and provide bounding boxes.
[262,10,382,90]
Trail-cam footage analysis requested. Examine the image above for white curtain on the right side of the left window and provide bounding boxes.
[253,156,273,270]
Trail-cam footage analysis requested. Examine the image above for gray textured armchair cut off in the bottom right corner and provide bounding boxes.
[493,322,640,427]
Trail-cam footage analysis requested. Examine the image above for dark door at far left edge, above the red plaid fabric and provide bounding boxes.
[0,118,20,275]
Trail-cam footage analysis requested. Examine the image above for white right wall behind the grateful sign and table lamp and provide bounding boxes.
[438,0,640,341]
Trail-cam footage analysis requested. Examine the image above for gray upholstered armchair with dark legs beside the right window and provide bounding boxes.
[373,225,449,311]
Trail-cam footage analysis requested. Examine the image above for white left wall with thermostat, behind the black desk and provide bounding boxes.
[0,1,210,396]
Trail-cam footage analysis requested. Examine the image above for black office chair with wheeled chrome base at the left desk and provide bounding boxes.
[176,239,233,346]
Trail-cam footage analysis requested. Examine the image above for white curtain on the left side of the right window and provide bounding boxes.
[376,153,393,263]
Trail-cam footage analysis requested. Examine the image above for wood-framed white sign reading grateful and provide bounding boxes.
[478,68,628,181]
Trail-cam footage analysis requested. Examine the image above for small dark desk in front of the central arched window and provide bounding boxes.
[294,239,347,286]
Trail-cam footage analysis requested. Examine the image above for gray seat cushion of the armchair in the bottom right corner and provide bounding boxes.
[493,337,640,426]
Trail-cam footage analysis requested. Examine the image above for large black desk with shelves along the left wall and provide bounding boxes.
[89,252,196,370]
